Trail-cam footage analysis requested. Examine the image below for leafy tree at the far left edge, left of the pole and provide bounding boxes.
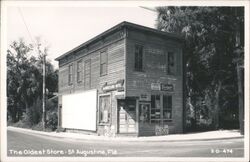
[7,39,32,122]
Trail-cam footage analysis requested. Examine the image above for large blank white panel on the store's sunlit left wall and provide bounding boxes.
[62,90,97,131]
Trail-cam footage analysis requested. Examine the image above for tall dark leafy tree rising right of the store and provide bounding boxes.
[156,7,244,132]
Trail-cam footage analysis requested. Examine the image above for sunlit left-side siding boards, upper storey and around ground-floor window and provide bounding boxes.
[59,36,125,134]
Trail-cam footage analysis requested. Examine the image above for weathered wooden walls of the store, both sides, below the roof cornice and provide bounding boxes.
[59,25,183,135]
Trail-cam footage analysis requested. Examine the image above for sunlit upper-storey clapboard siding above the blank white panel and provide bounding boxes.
[59,39,125,94]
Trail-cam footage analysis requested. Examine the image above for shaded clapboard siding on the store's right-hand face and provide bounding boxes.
[126,30,183,135]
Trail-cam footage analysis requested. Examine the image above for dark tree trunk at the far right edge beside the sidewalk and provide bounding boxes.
[237,64,244,135]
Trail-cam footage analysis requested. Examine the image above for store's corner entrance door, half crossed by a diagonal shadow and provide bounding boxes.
[118,100,136,133]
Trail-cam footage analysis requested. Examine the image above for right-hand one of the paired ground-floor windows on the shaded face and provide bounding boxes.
[163,95,172,120]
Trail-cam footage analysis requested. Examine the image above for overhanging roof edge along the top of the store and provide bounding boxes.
[55,21,183,61]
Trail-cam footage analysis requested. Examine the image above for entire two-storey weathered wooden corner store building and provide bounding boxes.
[56,22,184,136]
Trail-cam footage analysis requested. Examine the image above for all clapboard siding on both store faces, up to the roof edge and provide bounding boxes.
[57,22,183,136]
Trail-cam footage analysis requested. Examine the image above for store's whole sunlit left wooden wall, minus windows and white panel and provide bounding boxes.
[59,31,125,133]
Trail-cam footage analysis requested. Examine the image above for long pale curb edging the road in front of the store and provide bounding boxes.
[7,126,244,142]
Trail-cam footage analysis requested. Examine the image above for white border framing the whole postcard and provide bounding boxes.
[0,0,250,162]
